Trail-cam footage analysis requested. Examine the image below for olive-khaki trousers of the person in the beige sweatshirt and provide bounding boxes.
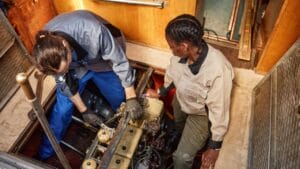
[172,95,209,169]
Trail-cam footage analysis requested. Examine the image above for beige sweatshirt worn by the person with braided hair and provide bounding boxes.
[164,45,234,141]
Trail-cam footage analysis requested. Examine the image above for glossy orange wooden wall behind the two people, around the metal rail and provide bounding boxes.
[53,0,196,49]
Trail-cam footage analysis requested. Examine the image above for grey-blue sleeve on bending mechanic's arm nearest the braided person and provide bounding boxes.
[99,26,135,87]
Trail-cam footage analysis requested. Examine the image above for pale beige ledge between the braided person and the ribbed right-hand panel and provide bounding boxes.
[215,68,263,169]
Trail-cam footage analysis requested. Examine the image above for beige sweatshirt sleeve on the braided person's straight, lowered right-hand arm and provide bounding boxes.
[206,69,233,142]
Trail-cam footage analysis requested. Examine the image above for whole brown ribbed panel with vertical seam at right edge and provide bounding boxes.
[248,40,300,169]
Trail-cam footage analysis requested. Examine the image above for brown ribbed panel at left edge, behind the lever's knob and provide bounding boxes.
[0,10,31,110]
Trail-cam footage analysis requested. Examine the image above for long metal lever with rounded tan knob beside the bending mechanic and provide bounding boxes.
[16,73,71,169]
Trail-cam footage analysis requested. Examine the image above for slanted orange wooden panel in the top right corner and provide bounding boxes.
[256,0,300,73]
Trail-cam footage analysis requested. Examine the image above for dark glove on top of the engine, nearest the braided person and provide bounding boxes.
[125,97,143,120]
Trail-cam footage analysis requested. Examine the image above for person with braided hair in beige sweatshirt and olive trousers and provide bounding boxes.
[146,14,234,169]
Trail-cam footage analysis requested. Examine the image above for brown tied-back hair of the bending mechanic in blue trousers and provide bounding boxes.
[32,31,68,74]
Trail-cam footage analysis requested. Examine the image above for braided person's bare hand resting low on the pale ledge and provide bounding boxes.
[200,149,220,169]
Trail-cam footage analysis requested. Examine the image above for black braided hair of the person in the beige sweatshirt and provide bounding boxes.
[165,14,203,47]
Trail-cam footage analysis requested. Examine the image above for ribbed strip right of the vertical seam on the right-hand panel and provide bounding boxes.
[274,45,300,169]
